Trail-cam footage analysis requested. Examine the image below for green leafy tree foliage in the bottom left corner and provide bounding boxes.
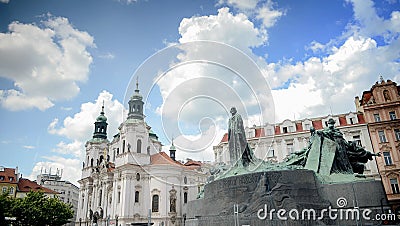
[0,192,73,226]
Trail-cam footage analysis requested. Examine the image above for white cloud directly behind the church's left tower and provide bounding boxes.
[30,91,125,185]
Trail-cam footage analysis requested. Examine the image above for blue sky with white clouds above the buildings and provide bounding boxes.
[0,0,400,184]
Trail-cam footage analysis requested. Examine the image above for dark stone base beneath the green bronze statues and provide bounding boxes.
[185,169,389,226]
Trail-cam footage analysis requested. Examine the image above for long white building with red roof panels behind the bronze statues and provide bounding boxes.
[213,112,379,177]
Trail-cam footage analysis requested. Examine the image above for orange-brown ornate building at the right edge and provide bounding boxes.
[355,78,400,208]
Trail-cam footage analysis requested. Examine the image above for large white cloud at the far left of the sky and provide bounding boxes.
[0,16,94,111]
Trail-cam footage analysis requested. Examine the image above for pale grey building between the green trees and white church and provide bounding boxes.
[36,169,79,225]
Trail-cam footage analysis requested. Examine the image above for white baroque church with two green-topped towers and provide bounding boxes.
[75,83,207,226]
